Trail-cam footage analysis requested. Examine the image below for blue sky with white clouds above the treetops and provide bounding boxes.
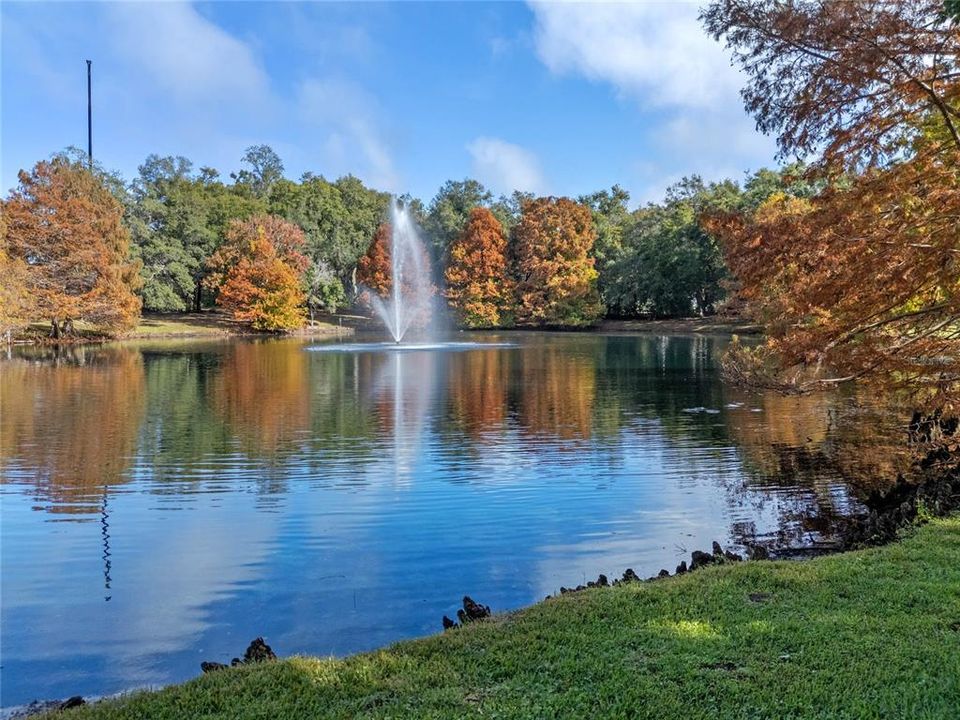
[0,2,774,204]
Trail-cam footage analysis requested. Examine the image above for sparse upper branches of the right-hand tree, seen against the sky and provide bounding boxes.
[703,0,960,169]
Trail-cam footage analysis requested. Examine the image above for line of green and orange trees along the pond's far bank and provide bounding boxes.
[0,145,802,336]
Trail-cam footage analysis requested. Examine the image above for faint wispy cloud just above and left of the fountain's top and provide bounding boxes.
[299,79,401,192]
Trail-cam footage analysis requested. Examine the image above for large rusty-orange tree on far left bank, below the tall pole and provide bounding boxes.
[3,157,140,337]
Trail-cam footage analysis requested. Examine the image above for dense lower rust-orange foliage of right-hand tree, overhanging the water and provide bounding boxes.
[707,146,960,404]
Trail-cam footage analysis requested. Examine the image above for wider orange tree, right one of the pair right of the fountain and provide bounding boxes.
[513,197,603,327]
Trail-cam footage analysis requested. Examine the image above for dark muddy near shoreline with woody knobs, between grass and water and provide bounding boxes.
[16,468,960,720]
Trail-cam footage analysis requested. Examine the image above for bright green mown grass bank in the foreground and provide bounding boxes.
[54,517,960,720]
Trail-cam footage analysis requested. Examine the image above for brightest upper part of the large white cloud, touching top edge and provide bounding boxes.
[530,1,742,108]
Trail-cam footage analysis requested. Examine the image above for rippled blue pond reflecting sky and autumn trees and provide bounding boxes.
[0,333,900,707]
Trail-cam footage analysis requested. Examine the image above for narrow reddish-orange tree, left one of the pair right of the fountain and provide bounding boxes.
[445,207,513,328]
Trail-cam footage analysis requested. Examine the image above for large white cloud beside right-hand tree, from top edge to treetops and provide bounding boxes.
[529,0,776,202]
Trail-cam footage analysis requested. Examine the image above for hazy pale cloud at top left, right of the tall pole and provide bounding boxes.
[103,2,269,105]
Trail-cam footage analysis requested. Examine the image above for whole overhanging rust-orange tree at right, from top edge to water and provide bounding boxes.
[704,0,960,407]
